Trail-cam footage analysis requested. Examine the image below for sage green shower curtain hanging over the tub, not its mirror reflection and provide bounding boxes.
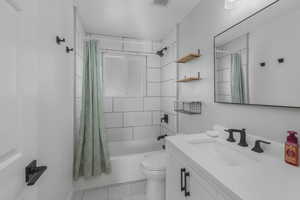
[74,41,111,180]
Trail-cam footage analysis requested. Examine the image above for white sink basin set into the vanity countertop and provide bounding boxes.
[188,139,258,166]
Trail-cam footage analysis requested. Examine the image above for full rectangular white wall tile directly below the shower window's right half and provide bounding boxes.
[113,98,143,112]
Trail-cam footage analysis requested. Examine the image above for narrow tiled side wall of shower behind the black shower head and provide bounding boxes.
[160,30,177,135]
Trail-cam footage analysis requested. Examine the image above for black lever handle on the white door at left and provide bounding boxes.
[25,160,47,186]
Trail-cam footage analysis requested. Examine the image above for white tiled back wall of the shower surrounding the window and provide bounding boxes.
[99,38,160,142]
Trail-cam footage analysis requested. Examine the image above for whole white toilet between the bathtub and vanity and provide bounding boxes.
[141,151,167,200]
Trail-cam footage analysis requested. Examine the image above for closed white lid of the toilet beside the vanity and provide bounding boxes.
[142,152,167,171]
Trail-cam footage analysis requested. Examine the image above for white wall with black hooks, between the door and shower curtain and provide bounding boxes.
[36,0,74,200]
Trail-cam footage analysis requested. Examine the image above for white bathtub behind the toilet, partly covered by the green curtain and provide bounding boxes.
[74,140,162,191]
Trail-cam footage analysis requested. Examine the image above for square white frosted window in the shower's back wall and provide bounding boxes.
[103,53,146,97]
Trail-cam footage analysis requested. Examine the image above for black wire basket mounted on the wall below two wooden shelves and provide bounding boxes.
[174,101,202,115]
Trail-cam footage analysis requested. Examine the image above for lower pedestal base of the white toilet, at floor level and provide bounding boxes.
[146,179,165,200]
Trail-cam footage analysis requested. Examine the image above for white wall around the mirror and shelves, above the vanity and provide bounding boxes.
[179,0,300,142]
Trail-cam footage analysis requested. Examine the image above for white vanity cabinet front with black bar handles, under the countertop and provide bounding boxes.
[166,154,216,200]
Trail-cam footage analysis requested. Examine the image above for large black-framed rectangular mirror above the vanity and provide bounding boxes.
[214,1,300,107]
